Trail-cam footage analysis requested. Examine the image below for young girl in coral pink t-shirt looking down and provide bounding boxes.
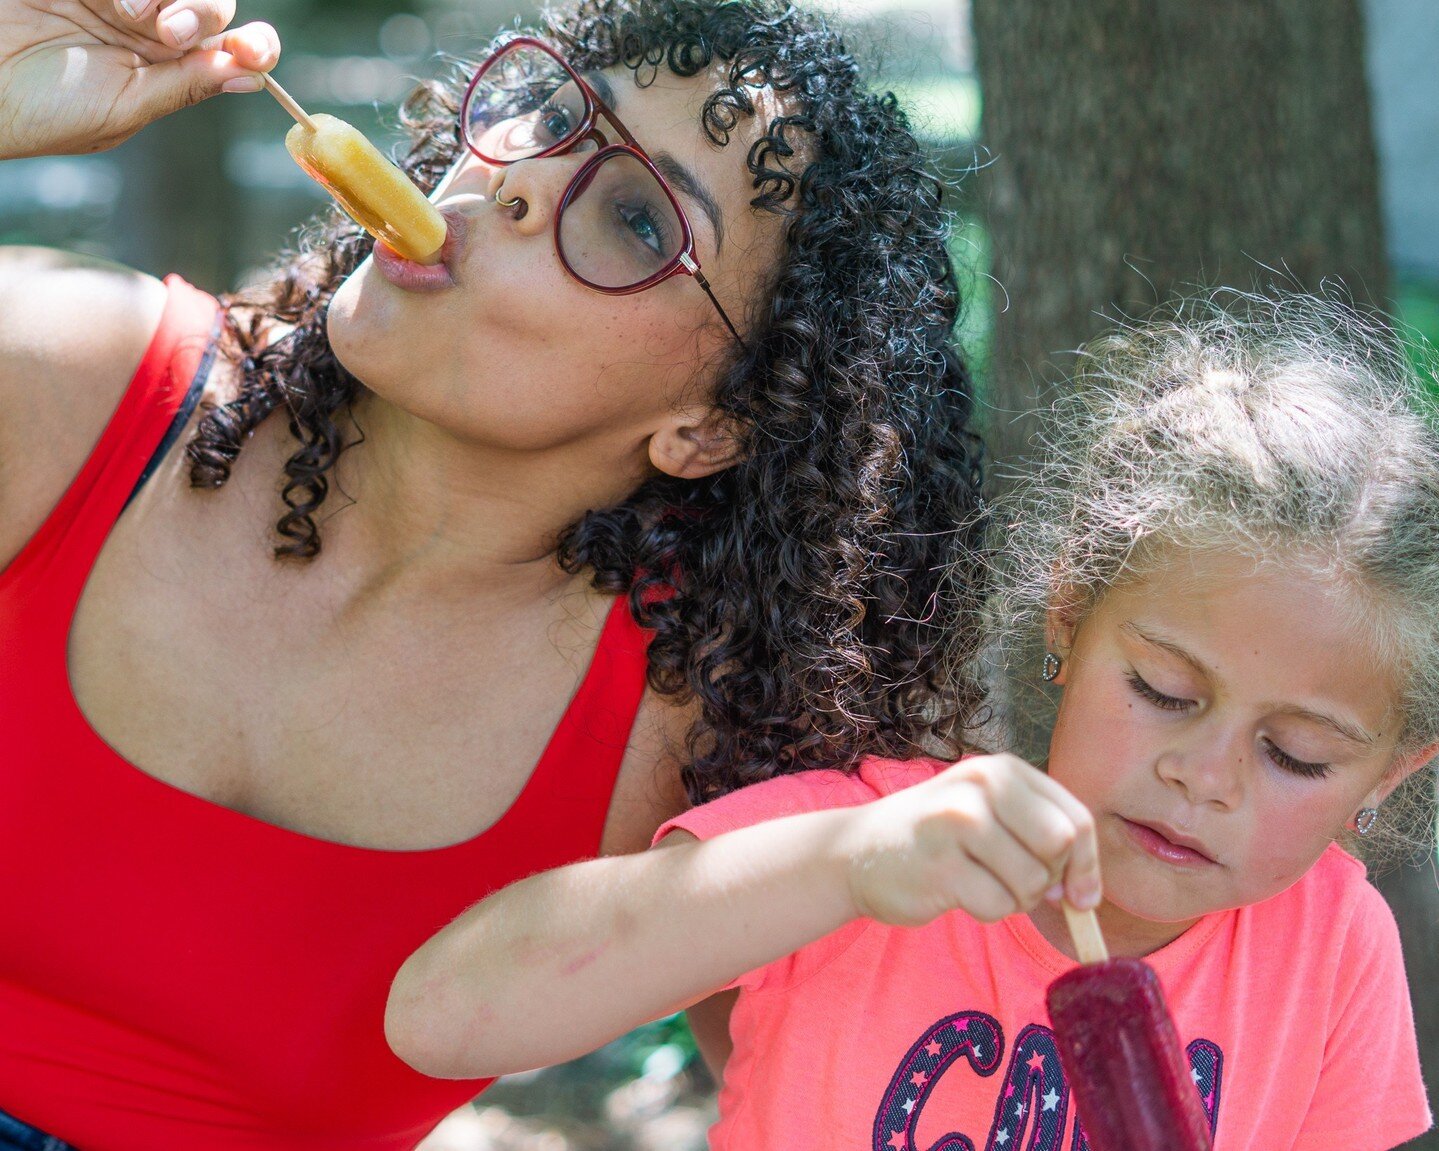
[387,299,1439,1151]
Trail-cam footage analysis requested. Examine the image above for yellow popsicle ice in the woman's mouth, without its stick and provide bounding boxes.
[285,112,445,263]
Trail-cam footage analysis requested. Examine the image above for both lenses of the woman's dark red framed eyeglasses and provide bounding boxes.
[463,45,685,289]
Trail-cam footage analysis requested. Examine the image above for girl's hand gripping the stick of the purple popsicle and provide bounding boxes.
[835,755,1099,927]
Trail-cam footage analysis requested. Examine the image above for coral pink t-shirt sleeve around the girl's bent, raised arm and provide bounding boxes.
[655,760,944,991]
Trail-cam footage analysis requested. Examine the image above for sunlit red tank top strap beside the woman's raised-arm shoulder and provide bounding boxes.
[0,275,220,609]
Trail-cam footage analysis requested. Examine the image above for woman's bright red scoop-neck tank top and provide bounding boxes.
[0,276,648,1151]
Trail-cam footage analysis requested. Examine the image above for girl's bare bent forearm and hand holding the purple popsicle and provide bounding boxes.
[386,755,1099,1079]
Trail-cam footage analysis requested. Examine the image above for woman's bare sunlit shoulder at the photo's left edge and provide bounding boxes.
[0,247,165,568]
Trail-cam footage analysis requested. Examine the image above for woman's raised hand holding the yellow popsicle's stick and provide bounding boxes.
[0,0,279,158]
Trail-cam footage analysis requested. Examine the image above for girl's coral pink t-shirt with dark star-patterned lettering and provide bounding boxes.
[656,760,1430,1151]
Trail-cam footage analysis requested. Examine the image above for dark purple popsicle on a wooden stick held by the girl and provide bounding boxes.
[1046,906,1213,1151]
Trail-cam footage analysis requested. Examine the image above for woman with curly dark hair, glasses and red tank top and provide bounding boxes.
[0,0,980,1151]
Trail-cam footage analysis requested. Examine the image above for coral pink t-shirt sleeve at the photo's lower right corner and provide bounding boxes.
[1294,883,1433,1151]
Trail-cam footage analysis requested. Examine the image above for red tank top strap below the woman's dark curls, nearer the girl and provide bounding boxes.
[505,596,653,859]
